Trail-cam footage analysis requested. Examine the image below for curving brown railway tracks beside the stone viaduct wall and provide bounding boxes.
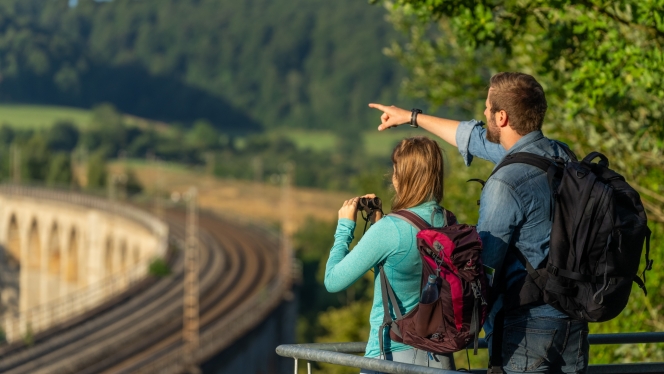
[0,211,279,374]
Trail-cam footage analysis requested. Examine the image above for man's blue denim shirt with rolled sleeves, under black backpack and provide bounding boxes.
[456,120,569,336]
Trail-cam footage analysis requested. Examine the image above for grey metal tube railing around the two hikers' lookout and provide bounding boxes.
[277,332,664,374]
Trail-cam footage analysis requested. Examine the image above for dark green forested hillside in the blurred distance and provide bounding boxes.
[0,0,403,133]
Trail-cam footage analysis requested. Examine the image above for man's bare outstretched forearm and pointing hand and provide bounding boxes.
[369,103,459,147]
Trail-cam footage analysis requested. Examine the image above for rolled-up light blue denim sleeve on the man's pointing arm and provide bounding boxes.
[456,119,507,166]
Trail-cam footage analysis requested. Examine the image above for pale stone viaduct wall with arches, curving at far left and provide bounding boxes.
[0,185,168,341]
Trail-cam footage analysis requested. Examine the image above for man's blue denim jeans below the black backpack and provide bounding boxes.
[503,317,589,374]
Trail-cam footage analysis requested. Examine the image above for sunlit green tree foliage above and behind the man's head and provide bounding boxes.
[388,0,664,221]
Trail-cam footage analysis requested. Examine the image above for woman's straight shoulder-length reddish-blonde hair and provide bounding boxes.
[392,136,445,211]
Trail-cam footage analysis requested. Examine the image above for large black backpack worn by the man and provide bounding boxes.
[492,147,653,322]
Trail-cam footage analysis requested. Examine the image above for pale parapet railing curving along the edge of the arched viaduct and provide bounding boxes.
[0,184,168,341]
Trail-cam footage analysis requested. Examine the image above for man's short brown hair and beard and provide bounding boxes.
[489,72,547,135]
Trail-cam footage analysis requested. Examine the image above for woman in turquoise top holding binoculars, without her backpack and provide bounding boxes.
[325,136,454,374]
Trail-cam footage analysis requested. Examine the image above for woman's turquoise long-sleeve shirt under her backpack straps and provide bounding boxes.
[325,201,444,357]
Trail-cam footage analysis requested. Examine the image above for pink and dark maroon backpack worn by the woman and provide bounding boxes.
[378,210,487,354]
